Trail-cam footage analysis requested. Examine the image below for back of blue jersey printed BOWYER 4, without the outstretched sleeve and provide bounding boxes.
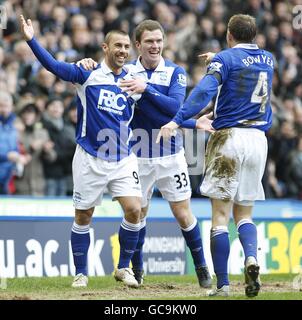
[207,44,274,131]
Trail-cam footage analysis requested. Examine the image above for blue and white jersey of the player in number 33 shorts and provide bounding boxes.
[127,58,188,158]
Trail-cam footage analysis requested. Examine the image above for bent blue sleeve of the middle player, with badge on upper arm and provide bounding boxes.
[144,67,187,117]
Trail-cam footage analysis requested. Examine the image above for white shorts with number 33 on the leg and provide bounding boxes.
[137,149,191,208]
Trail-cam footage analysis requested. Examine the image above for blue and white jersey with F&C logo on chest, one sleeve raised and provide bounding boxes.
[27,38,141,161]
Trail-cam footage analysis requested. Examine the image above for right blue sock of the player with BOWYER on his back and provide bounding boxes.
[237,219,257,260]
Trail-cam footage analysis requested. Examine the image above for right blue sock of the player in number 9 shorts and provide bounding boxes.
[117,218,141,269]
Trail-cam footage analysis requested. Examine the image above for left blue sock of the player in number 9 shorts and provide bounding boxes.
[71,222,90,276]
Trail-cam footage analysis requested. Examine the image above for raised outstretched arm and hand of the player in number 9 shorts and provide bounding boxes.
[20,15,90,84]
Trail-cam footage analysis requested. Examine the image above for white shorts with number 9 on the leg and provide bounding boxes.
[72,145,142,210]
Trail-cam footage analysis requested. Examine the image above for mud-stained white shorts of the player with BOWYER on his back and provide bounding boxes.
[200,128,267,204]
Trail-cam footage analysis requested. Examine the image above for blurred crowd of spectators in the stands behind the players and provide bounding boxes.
[0,0,302,199]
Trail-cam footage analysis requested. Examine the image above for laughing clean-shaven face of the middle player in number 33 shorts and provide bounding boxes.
[136,29,164,68]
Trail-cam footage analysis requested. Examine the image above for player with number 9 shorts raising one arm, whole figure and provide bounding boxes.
[20,16,141,287]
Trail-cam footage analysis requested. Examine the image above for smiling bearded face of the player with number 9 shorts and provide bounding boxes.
[103,34,130,71]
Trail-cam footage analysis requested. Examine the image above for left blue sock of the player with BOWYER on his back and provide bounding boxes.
[211,226,230,289]
